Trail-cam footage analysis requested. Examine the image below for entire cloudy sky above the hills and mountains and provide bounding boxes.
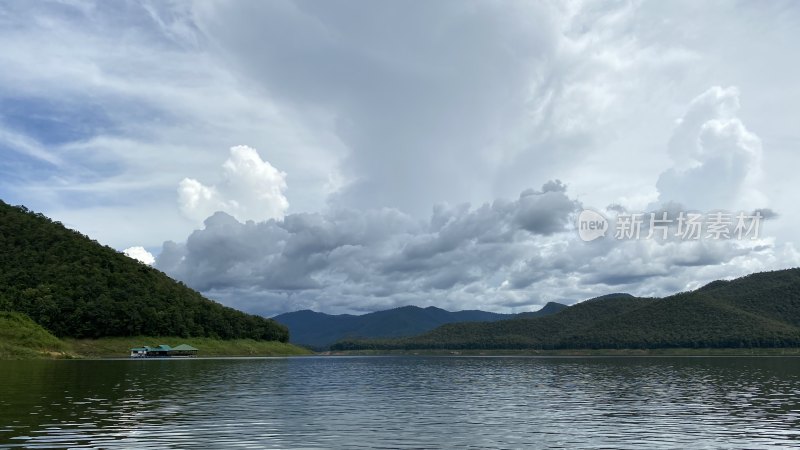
[0,0,800,315]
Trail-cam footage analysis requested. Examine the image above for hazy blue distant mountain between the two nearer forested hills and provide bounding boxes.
[273,302,567,349]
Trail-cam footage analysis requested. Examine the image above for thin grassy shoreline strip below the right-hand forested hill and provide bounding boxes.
[326,348,800,356]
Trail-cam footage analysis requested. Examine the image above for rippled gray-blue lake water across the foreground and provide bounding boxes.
[0,357,800,449]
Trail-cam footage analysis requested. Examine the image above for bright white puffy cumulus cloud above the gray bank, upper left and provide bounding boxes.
[178,145,289,221]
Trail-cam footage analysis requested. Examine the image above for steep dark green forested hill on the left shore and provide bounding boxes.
[0,201,289,342]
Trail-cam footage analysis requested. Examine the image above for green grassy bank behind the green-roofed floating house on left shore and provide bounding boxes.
[64,336,312,358]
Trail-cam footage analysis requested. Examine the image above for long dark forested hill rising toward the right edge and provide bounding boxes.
[332,269,800,350]
